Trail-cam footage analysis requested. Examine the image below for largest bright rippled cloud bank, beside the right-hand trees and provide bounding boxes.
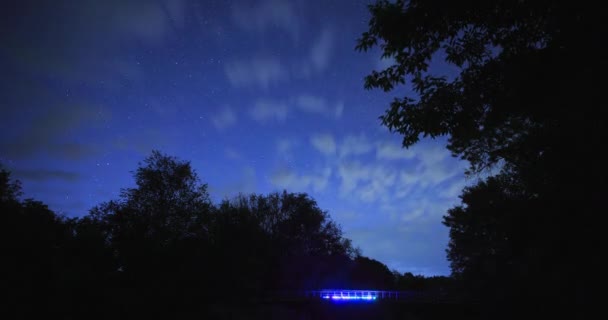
[310,134,463,202]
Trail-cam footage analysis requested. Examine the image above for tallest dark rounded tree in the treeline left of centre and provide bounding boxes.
[90,151,211,303]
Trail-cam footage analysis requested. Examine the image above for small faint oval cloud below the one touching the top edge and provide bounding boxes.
[224,56,289,89]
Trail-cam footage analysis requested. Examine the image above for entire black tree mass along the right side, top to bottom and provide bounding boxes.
[357,0,608,312]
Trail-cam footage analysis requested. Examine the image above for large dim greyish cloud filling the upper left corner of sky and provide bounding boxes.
[2,0,188,90]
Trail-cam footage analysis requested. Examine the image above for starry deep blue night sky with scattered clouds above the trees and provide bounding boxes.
[0,0,469,275]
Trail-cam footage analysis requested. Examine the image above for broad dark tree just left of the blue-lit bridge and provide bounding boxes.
[220,191,355,289]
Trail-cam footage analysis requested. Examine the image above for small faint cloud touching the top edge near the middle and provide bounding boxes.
[232,0,300,39]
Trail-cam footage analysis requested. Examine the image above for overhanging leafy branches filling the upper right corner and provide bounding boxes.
[357,0,606,172]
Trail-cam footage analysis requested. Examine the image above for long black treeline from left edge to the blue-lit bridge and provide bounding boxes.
[0,152,449,318]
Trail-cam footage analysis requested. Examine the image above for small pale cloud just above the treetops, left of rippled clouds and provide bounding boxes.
[270,167,332,192]
